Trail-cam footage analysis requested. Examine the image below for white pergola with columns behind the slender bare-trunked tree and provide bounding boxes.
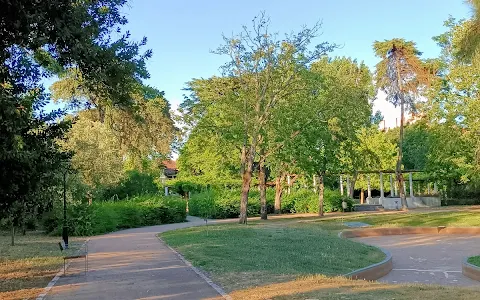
[339,170,441,210]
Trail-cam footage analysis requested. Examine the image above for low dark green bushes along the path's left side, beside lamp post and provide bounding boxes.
[43,195,186,236]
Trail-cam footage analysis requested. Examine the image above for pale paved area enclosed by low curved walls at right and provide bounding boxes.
[355,234,480,287]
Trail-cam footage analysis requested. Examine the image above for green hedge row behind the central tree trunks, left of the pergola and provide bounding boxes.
[188,189,353,219]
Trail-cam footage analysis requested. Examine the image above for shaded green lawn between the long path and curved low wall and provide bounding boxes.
[161,222,385,291]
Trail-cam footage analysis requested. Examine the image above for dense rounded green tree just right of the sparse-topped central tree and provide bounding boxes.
[285,58,374,216]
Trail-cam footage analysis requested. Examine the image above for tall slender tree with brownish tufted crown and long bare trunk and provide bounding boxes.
[373,39,430,210]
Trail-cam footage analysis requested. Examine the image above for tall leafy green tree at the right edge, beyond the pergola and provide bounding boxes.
[422,17,480,185]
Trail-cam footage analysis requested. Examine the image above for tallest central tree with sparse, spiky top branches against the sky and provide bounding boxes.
[199,14,332,223]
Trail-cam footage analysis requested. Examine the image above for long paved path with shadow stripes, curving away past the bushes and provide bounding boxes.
[46,217,223,300]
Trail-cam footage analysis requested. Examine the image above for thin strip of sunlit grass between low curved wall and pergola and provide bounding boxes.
[314,211,480,227]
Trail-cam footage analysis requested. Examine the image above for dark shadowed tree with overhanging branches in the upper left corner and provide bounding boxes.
[0,0,150,241]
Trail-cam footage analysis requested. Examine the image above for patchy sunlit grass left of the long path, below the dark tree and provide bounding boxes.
[0,232,83,300]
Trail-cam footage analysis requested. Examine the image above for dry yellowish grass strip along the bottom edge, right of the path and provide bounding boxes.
[220,275,480,300]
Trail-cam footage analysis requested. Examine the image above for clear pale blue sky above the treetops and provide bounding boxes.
[49,0,470,124]
